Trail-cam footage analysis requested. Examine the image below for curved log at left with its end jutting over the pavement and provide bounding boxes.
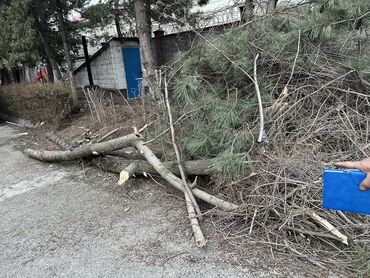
[25,134,140,162]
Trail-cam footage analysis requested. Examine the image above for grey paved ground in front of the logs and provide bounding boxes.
[0,118,346,277]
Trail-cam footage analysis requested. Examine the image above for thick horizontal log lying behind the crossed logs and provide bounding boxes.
[93,156,214,176]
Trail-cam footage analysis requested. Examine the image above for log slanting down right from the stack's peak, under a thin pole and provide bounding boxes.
[133,140,239,211]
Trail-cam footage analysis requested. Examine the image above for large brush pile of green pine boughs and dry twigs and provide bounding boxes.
[163,7,370,271]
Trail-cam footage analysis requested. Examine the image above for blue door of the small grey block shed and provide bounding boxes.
[122,48,143,99]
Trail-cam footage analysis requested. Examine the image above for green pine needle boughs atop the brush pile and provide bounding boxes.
[167,0,370,181]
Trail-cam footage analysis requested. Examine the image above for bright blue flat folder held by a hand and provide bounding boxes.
[322,169,370,214]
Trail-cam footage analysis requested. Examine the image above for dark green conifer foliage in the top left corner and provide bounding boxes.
[0,0,88,67]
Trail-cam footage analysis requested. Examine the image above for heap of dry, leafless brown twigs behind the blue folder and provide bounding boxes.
[207,45,370,272]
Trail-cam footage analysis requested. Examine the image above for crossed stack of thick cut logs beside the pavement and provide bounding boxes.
[25,116,238,248]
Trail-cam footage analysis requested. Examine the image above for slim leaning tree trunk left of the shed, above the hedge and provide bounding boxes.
[56,0,78,107]
